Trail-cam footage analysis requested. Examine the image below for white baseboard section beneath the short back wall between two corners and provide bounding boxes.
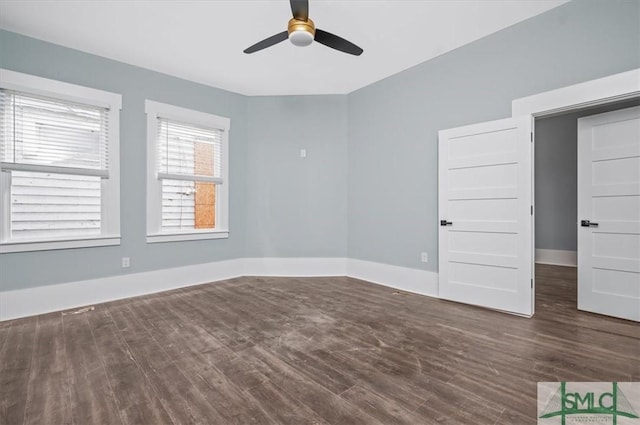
[242,258,347,277]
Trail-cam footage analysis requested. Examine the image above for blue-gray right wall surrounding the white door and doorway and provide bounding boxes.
[348,0,640,271]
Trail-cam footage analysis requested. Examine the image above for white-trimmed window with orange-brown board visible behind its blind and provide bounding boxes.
[145,100,229,242]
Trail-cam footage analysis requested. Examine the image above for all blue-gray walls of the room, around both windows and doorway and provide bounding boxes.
[0,0,640,290]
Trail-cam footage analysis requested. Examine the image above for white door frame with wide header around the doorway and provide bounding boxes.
[511,68,640,315]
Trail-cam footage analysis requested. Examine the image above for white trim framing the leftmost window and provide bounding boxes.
[0,68,122,254]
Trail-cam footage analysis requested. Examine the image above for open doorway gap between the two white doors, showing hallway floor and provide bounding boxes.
[534,97,640,315]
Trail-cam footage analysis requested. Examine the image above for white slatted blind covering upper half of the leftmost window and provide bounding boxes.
[0,90,109,178]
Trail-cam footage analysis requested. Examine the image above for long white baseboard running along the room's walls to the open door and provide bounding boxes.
[0,258,438,321]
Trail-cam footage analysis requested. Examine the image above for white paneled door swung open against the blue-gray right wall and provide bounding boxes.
[438,116,533,316]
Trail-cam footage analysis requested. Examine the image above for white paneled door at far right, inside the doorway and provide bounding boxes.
[578,107,640,321]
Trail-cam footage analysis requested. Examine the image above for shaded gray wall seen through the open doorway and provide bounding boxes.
[535,101,640,251]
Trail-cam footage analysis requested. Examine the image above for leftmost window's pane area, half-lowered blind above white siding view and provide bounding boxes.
[0,90,109,241]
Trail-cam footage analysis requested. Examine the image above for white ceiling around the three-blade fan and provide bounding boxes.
[0,0,567,95]
